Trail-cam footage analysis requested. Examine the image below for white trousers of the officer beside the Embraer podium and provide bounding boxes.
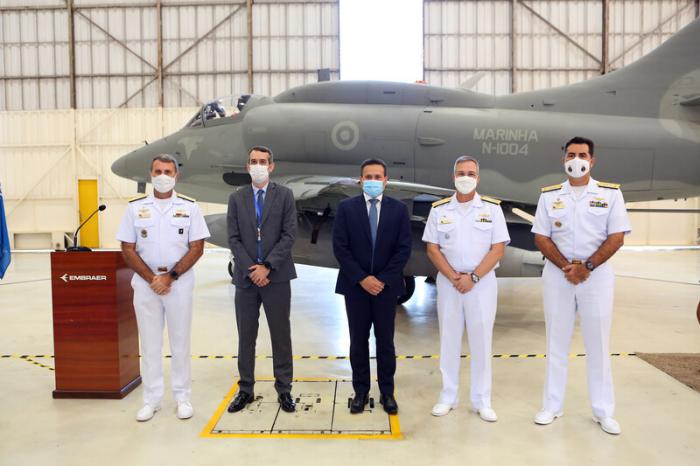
[131,270,194,406]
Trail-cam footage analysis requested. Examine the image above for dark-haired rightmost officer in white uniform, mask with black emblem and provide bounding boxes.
[532,137,631,434]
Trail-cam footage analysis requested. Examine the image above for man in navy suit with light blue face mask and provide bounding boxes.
[333,159,411,414]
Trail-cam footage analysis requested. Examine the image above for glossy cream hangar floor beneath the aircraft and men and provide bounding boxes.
[0,250,700,465]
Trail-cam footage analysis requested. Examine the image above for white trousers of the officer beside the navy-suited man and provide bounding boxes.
[437,271,498,410]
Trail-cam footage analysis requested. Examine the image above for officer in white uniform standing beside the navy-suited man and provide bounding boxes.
[423,156,510,422]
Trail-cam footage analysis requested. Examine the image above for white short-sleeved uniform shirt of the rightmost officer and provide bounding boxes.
[532,178,632,261]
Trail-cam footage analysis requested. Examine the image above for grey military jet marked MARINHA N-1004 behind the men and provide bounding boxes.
[112,19,700,301]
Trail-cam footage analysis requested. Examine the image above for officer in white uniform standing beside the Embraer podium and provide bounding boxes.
[117,154,209,421]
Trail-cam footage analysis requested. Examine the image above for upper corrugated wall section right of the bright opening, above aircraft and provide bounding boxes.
[423,0,698,95]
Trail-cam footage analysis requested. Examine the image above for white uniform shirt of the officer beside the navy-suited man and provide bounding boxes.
[423,193,510,273]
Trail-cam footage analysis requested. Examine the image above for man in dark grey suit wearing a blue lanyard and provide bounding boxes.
[228,146,297,413]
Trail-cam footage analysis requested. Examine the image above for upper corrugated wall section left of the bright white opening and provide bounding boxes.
[0,0,340,110]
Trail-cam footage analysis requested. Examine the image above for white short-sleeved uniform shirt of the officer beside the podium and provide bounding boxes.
[117,191,210,273]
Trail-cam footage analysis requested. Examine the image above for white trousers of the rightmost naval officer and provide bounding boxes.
[542,261,615,418]
